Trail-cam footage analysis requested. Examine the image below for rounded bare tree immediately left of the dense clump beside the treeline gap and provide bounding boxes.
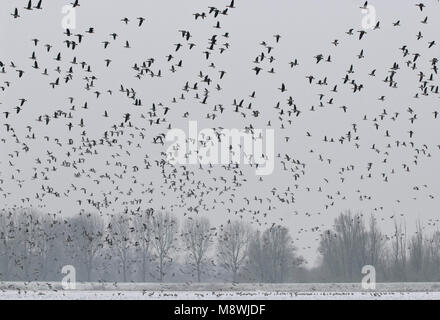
[217,221,251,282]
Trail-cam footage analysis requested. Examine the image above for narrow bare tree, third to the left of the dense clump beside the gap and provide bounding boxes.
[151,212,178,282]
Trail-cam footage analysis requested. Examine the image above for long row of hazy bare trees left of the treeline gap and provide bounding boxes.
[0,209,301,282]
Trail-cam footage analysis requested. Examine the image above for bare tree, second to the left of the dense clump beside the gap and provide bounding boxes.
[182,217,212,282]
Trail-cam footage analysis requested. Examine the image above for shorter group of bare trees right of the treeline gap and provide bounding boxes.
[314,211,440,282]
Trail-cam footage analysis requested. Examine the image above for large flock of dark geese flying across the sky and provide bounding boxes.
[0,0,440,258]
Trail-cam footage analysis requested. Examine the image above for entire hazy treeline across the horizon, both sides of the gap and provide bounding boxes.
[0,208,440,283]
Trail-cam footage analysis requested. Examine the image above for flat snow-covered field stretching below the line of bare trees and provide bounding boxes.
[0,282,440,300]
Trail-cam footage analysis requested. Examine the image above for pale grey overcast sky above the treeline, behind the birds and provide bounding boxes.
[0,0,440,263]
